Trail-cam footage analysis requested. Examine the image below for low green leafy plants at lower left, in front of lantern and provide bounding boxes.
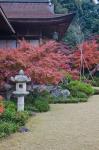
[0,100,29,138]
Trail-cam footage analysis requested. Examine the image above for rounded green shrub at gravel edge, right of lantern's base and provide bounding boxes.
[35,99,50,112]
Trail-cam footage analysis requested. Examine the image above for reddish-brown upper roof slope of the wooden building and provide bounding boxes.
[0,3,54,19]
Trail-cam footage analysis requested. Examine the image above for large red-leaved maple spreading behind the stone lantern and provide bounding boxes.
[0,41,77,84]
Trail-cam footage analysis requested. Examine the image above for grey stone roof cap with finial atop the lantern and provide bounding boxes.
[11,70,31,83]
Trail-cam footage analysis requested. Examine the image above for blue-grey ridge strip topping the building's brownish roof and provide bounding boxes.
[0,0,48,3]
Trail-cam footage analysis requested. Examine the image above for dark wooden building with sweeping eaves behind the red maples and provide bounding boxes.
[0,0,75,48]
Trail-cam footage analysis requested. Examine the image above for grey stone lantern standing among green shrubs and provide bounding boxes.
[11,70,31,111]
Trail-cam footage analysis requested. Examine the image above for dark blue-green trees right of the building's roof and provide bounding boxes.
[53,0,99,47]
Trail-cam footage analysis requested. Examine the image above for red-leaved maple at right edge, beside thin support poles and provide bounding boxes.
[69,40,99,70]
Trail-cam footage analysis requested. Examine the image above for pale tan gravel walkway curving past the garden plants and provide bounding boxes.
[0,96,99,150]
